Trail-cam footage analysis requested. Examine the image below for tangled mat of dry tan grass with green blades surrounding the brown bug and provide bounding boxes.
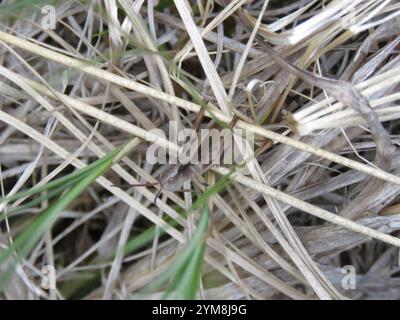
[0,0,400,299]
